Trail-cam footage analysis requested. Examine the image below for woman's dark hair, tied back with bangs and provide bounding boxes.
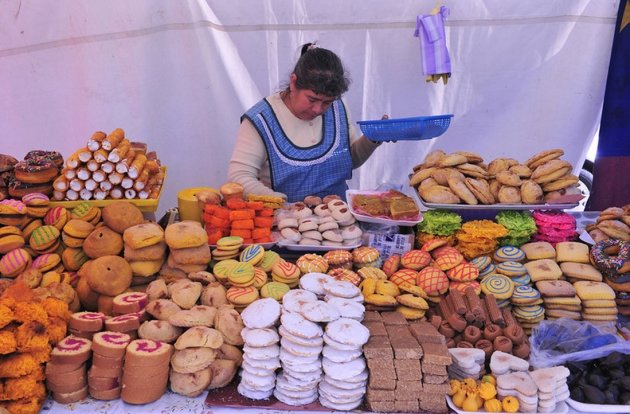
[293,43,350,98]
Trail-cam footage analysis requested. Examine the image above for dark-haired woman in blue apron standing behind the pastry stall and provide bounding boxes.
[228,43,388,202]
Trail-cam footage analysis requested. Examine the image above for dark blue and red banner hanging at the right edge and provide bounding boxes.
[587,0,630,211]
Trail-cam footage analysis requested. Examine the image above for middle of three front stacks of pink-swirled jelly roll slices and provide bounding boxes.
[88,331,131,400]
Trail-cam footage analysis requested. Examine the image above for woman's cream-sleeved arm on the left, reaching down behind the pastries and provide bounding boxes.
[228,119,287,199]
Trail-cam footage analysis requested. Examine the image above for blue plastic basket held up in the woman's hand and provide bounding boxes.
[357,114,453,141]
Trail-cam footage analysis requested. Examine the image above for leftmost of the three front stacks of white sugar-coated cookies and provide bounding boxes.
[237,298,281,400]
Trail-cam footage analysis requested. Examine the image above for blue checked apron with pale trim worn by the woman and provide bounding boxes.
[243,99,352,202]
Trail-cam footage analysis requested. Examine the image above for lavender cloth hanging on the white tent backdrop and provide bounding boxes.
[413,6,451,84]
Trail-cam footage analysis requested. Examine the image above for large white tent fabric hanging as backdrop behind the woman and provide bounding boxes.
[0,0,618,212]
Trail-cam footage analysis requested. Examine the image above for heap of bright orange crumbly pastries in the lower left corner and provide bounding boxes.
[0,282,70,413]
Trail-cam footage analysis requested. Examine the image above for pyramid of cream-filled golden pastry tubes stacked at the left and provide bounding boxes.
[52,128,164,201]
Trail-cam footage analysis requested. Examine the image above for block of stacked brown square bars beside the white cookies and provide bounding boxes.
[363,311,452,413]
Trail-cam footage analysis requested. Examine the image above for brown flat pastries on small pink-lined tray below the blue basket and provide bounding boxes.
[350,190,420,220]
